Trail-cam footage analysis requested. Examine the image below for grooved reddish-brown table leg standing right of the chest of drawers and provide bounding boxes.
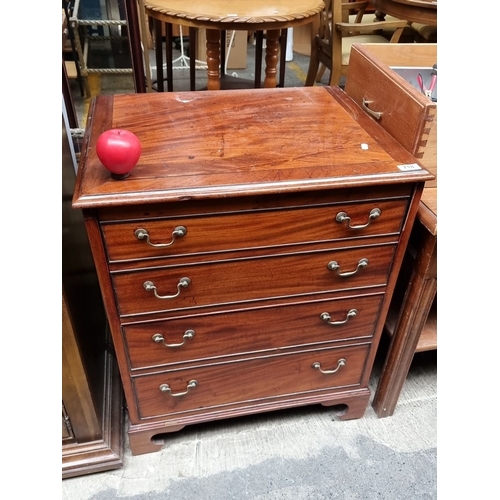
[372,224,437,418]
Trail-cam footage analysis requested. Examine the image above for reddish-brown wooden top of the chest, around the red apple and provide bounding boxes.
[73,87,433,208]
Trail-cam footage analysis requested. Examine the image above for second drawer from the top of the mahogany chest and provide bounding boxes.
[113,244,395,317]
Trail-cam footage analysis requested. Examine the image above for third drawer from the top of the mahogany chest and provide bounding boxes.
[123,292,383,370]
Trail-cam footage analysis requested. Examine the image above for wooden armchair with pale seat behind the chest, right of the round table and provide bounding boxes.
[306,0,407,86]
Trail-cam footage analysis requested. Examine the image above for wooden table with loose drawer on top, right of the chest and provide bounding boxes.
[345,44,437,417]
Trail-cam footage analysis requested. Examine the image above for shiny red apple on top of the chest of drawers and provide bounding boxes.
[96,128,142,179]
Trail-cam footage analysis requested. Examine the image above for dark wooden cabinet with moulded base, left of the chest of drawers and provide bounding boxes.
[61,106,124,479]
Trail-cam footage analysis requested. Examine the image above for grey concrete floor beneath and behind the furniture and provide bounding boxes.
[62,36,437,500]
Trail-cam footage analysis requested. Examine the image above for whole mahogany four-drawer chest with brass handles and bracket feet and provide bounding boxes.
[73,87,433,454]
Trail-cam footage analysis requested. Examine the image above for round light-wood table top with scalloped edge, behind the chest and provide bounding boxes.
[144,0,325,30]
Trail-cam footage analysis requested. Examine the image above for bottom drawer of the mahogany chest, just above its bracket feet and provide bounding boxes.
[133,343,370,418]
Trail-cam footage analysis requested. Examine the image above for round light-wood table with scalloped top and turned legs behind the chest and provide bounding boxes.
[143,0,324,90]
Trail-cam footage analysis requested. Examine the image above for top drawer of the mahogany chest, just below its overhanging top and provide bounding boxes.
[102,198,408,262]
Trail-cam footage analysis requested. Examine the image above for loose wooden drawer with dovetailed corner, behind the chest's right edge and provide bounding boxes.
[345,43,437,186]
